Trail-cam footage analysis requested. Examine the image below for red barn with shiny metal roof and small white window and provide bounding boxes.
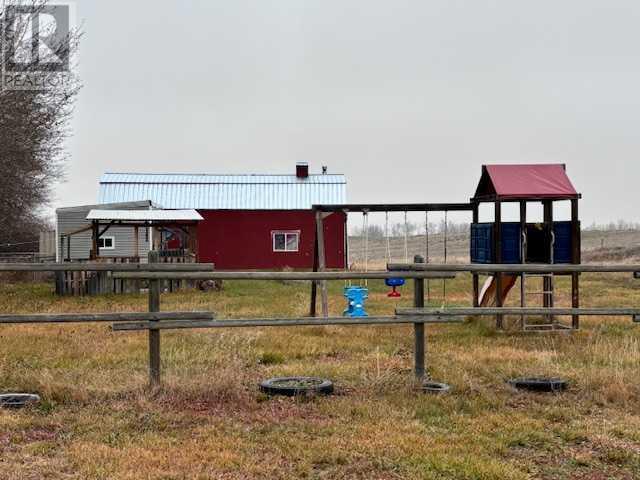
[99,163,346,270]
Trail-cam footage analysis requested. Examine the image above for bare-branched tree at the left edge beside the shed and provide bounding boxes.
[0,0,81,250]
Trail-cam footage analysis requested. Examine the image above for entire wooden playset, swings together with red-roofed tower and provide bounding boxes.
[310,164,581,331]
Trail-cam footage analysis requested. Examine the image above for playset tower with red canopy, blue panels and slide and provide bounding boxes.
[470,164,581,331]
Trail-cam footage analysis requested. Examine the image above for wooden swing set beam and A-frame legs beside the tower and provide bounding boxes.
[309,203,474,318]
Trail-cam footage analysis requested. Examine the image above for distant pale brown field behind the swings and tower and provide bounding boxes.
[349,230,640,266]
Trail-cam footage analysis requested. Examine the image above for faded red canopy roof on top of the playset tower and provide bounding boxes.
[474,164,580,200]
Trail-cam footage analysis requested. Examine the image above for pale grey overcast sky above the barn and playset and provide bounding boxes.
[53,0,640,223]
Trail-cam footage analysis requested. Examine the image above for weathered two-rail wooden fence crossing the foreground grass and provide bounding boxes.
[0,257,640,387]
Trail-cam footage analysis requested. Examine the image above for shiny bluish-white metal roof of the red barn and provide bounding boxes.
[98,173,347,210]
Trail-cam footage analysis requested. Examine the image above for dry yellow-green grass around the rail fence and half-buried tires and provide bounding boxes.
[0,268,640,480]
